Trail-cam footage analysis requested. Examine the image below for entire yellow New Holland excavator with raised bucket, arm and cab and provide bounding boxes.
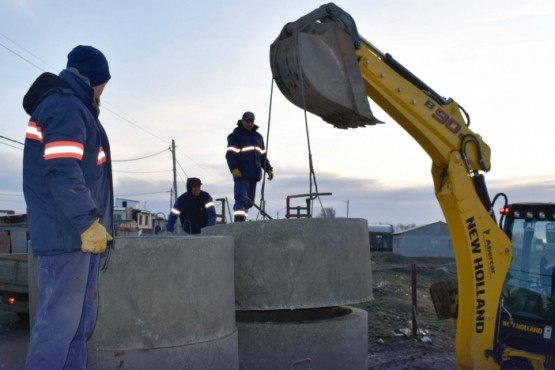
[270,3,555,370]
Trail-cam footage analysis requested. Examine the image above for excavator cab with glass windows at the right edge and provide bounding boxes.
[496,203,555,368]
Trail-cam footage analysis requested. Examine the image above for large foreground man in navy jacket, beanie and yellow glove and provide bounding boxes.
[23,45,113,370]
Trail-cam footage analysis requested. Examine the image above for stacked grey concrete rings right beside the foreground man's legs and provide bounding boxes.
[89,236,238,370]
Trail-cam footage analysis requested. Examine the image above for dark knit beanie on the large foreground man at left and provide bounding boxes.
[67,45,112,87]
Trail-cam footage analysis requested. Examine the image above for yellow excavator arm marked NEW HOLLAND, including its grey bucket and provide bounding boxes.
[270,3,512,369]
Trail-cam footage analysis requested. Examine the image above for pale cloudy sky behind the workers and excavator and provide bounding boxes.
[0,0,555,224]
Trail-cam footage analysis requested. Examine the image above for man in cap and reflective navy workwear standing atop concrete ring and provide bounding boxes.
[225,112,274,222]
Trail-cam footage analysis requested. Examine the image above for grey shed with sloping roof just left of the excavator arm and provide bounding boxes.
[393,221,455,258]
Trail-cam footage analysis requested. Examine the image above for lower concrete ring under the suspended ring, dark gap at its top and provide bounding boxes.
[237,307,368,370]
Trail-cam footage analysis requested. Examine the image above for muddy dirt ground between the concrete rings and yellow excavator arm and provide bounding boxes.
[357,253,456,370]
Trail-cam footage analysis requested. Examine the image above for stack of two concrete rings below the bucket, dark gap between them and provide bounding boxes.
[202,218,372,370]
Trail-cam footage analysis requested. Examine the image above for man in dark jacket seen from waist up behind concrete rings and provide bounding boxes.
[166,177,216,234]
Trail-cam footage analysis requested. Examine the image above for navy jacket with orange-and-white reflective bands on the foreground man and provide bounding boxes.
[23,70,113,256]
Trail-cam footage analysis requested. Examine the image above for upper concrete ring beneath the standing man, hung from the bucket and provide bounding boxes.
[202,218,372,310]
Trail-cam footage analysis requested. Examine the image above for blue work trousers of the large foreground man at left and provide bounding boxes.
[25,251,100,370]
